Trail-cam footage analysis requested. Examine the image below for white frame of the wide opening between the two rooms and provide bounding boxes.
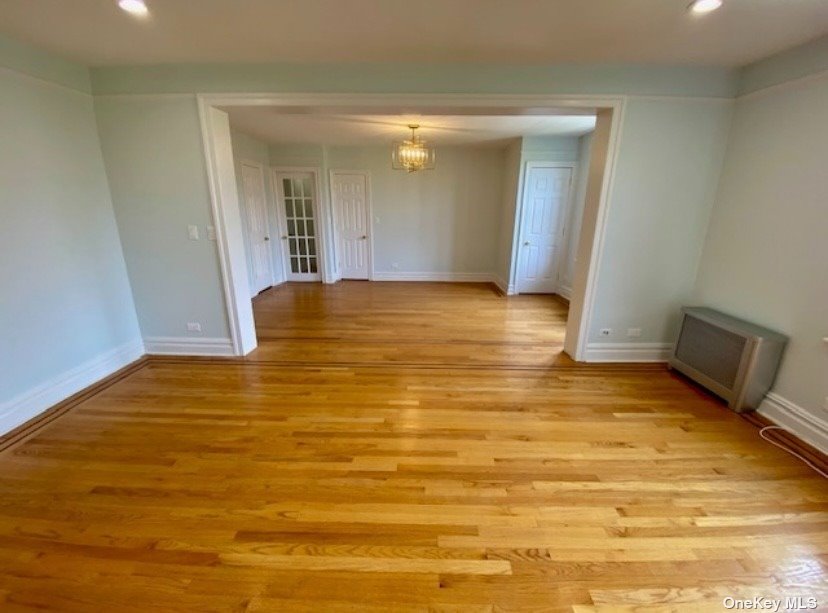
[195,92,629,361]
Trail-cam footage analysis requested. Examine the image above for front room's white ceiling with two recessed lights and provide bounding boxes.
[0,0,828,66]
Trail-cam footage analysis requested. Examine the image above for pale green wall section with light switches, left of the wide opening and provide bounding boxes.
[95,96,230,339]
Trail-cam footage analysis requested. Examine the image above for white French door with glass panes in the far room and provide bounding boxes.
[275,172,322,281]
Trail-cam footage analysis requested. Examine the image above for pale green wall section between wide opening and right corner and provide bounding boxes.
[589,99,732,343]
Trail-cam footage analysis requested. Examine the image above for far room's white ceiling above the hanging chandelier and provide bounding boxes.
[224,107,595,145]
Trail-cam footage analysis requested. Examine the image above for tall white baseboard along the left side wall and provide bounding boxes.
[0,341,144,434]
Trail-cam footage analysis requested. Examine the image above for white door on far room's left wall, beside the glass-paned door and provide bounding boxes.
[241,162,273,296]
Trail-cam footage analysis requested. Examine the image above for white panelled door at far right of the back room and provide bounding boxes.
[517,164,572,294]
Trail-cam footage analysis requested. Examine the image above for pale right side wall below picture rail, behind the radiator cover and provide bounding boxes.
[696,75,828,426]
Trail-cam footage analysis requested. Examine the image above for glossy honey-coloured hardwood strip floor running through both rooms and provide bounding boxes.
[0,282,828,612]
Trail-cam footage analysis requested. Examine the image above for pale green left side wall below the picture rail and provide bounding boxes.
[0,63,141,406]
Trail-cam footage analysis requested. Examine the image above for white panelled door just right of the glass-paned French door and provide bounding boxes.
[331,172,371,279]
